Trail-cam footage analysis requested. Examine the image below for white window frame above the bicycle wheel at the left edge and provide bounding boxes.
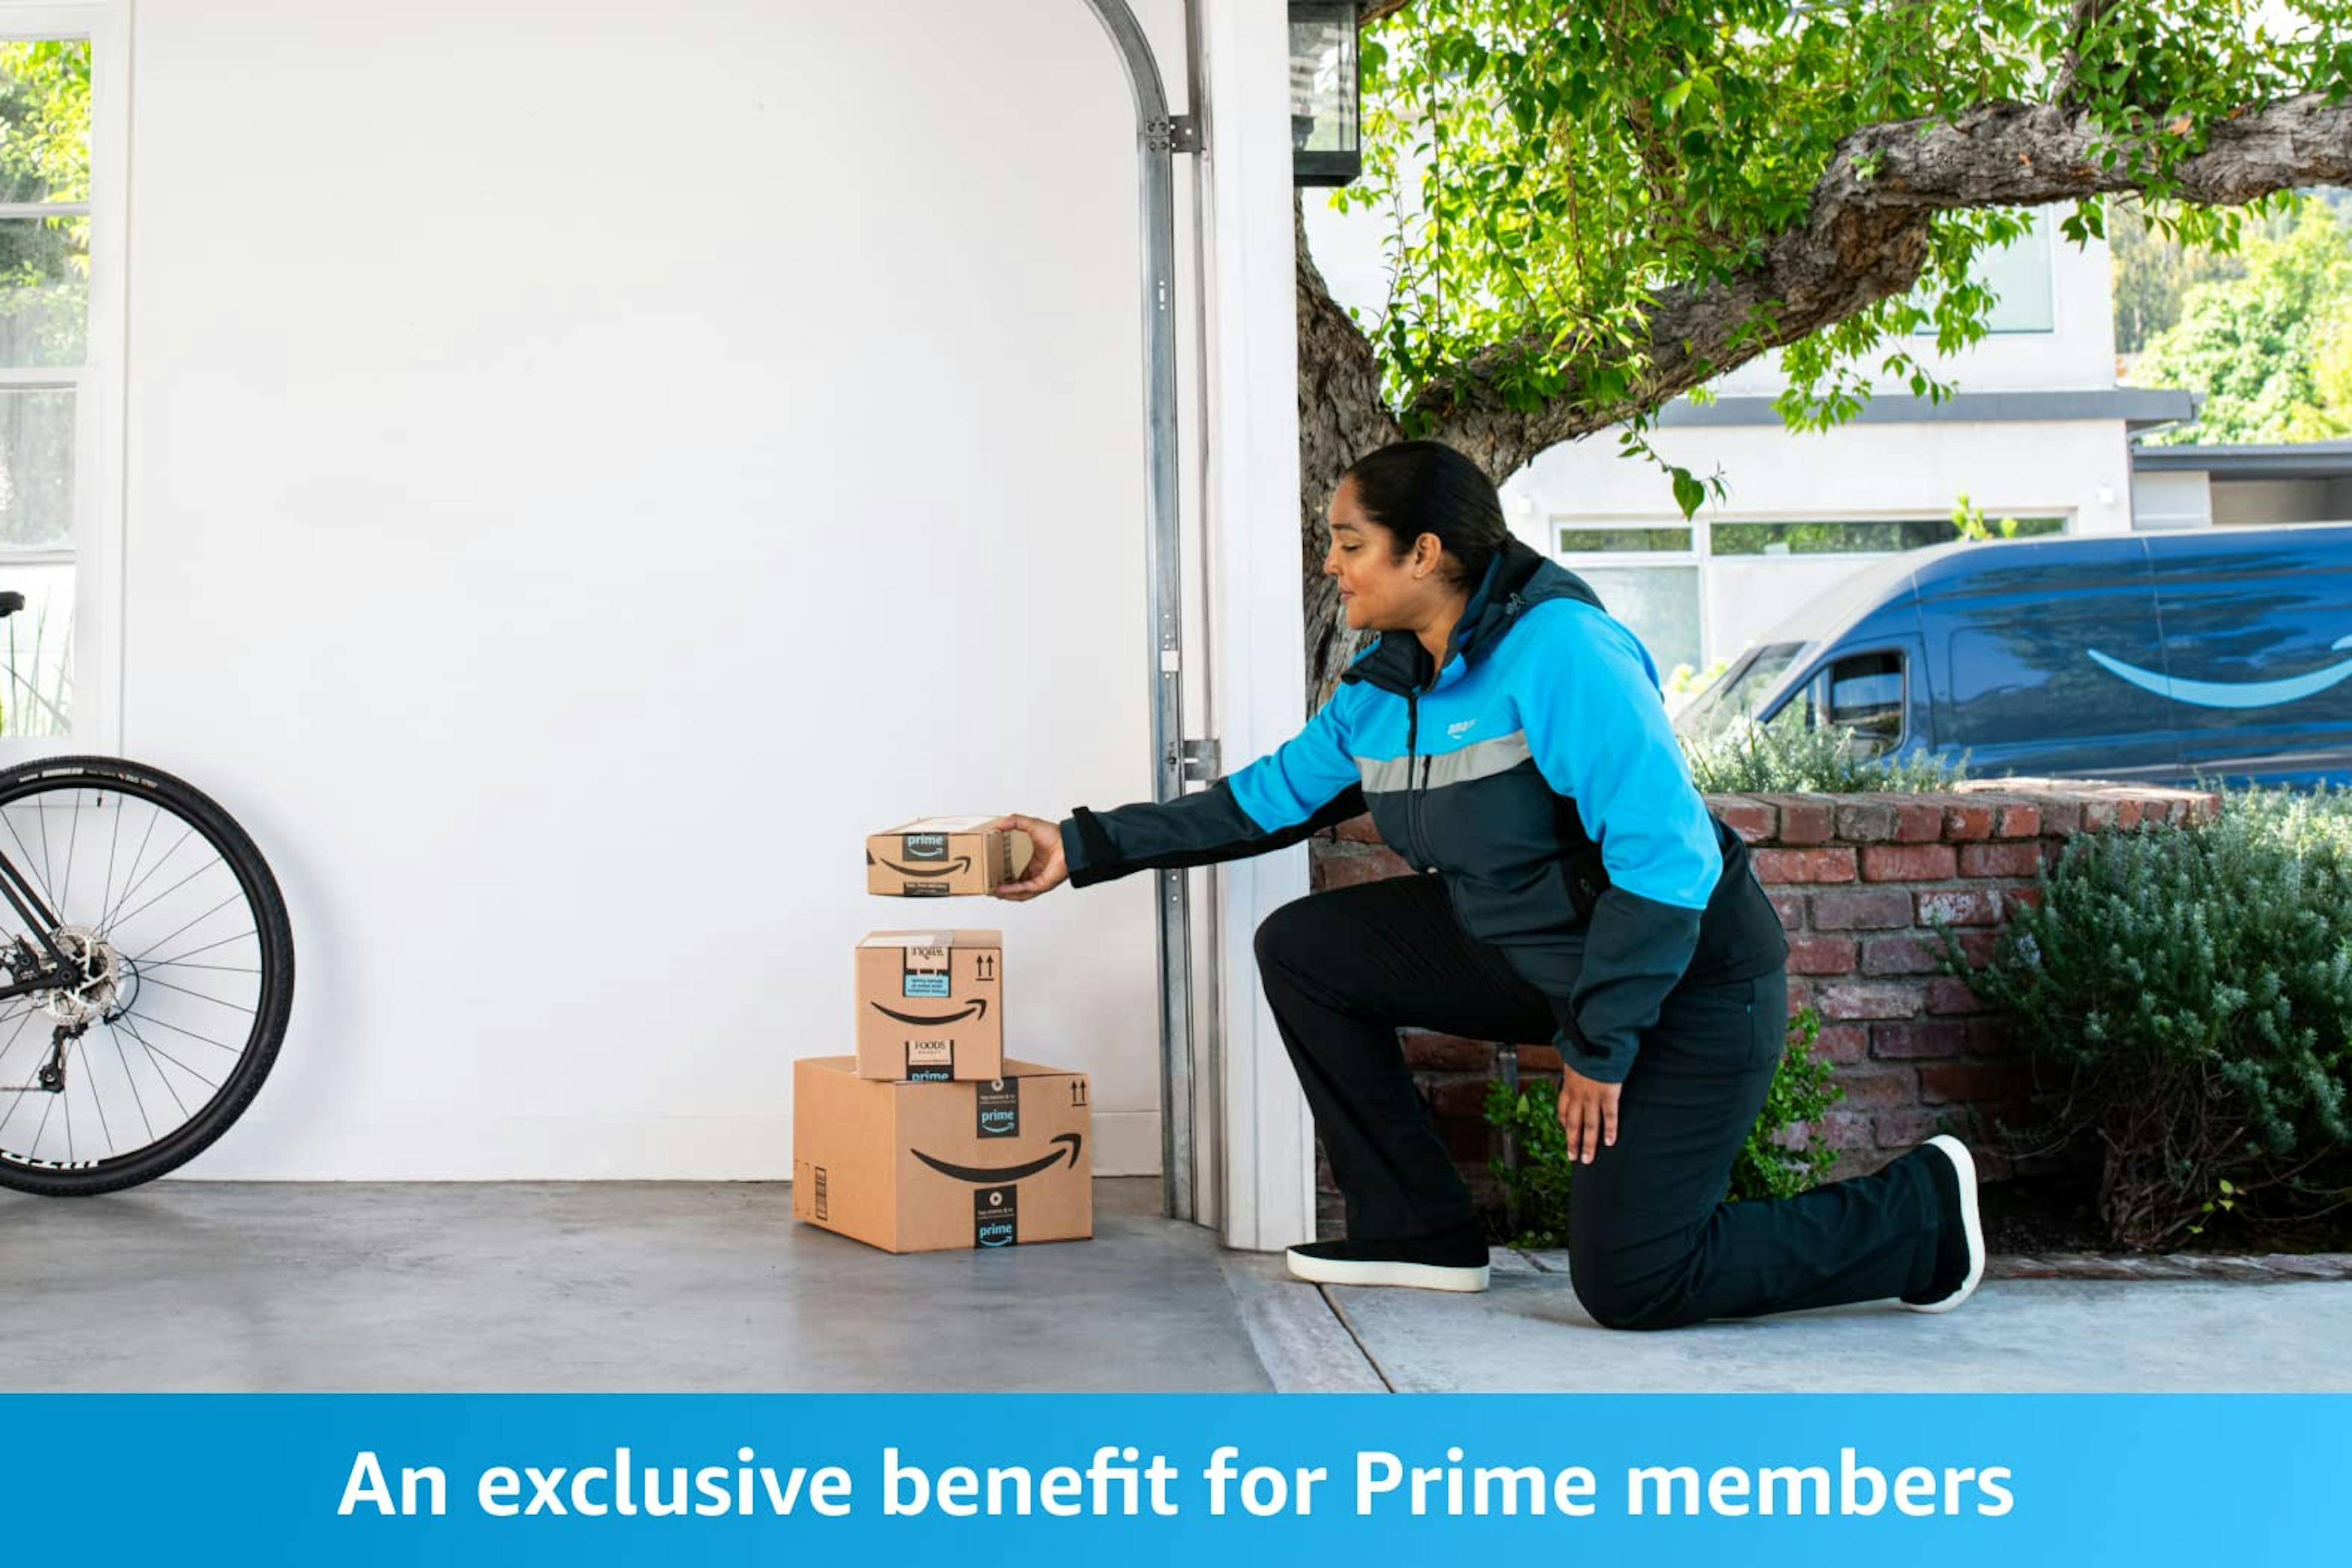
[0,0,129,766]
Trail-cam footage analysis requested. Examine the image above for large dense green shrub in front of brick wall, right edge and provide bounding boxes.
[1945,790,2352,1248]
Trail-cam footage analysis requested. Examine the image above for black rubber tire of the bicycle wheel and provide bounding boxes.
[0,757,294,1197]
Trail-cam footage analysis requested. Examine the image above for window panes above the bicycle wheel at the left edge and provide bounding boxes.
[0,38,92,736]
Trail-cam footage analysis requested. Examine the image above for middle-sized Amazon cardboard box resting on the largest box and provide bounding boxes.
[856,929,1005,1084]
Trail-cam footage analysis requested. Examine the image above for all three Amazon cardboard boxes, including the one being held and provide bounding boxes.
[793,818,1094,1253]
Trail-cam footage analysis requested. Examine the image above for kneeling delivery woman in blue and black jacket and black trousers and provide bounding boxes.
[997,442,1985,1329]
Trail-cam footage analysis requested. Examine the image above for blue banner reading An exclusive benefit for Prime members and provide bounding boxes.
[13,1394,2352,1568]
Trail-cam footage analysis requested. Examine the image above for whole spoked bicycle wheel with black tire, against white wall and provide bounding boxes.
[0,757,294,1197]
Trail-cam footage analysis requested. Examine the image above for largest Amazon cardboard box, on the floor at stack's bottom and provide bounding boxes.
[793,1055,1094,1253]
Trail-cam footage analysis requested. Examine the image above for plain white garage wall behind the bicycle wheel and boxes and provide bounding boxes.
[123,0,1183,1178]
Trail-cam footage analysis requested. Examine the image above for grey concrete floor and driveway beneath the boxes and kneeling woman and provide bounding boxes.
[0,1180,2352,1392]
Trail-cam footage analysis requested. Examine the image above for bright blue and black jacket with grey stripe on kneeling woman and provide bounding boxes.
[1061,541,1787,1084]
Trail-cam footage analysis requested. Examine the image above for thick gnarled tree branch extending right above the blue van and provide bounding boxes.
[1401,94,2352,482]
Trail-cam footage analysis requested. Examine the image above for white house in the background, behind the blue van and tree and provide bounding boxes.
[1308,209,2192,675]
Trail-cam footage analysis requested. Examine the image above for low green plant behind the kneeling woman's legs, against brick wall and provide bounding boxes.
[1487,1009,1846,1246]
